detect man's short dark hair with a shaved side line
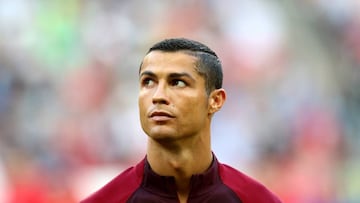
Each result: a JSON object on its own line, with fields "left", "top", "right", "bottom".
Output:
{"left": 143, "top": 38, "right": 223, "bottom": 94}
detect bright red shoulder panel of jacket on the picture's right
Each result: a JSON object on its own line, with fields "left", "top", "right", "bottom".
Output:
{"left": 219, "top": 163, "right": 281, "bottom": 203}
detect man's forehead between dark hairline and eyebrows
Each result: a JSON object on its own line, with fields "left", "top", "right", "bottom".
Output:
{"left": 140, "top": 51, "right": 199, "bottom": 75}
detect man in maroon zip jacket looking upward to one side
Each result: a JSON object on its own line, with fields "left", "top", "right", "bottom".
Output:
{"left": 83, "top": 38, "right": 280, "bottom": 203}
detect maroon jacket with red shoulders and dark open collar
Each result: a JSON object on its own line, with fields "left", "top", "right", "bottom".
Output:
{"left": 81, "top": 158, "right": 280, "bottom": 203}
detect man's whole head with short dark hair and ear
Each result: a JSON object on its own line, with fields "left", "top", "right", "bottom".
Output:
{"left": 139, "top": 39, "right": 225, "bottom": 140}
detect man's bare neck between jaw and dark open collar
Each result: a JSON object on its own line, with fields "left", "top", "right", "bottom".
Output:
{"left": 147, "top": 134, "right": 213, "bottom": 201}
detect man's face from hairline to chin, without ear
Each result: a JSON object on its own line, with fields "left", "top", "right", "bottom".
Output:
{"left": 139, "top": 51, "right": 210, "bottom": 140}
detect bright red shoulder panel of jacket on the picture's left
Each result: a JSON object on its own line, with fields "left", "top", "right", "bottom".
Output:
{"left": 81, "top": 160, "right": 145, "bottom": 203}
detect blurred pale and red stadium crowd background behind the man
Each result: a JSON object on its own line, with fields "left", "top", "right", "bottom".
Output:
{"left": 0, "top": 0, "right": 360, "bottom": 203}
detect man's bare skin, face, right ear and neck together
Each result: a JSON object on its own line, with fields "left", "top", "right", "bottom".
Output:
{"left": 138, "top": 51, "right": 226, "bottom": 202}
